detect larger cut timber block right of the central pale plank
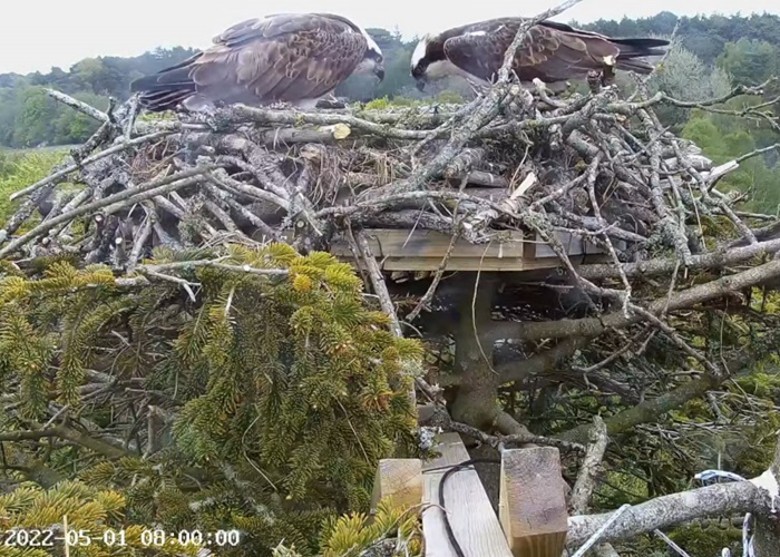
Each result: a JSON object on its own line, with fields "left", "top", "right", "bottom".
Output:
{"left": 498, "top": 447, "right": 569, "bottom": 557}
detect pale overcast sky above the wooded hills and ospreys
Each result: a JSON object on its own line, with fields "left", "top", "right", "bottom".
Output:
{"left": 0, "top": 0, "right": 780, "bottom": 73}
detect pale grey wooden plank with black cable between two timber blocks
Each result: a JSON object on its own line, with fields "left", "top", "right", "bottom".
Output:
{"left": 422, "top": 433, "right": 512, "bottom": 557}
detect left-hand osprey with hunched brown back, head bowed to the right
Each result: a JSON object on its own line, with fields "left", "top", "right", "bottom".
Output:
{"left": 130, "top": 13, "right": 385, "bottom": 112}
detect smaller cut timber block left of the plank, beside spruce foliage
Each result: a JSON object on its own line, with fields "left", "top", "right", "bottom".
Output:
{"left": 371, "top": 458, "right": 422, "bottom": 512}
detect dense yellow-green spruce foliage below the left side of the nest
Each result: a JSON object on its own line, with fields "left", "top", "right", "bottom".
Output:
{"left": 0, "top": 244, "right": 422, "bottom": 556}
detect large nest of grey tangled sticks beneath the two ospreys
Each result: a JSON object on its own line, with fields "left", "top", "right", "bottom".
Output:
{"left": 0, "top": 74, "right": 772, "bottom": 278}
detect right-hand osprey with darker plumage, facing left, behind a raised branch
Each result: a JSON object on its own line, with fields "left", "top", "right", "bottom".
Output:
{"left": 411, "top": 17, "right": 669, "bottom": 91}
